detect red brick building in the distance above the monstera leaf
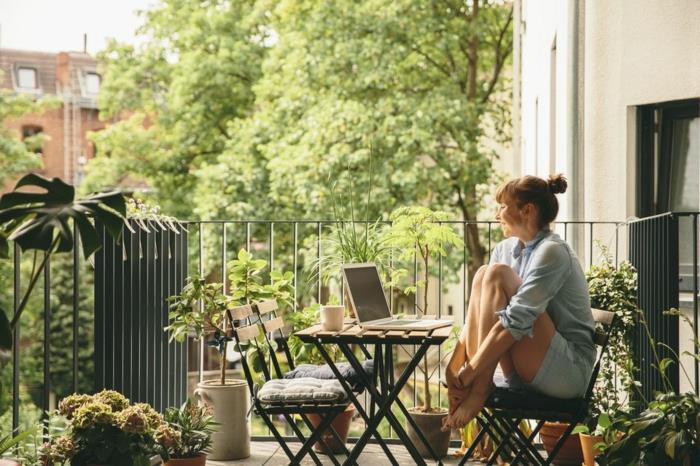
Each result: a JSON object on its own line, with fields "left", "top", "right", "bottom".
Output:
{"left": 0, "top": 49, "right": 105, "bottom": 188}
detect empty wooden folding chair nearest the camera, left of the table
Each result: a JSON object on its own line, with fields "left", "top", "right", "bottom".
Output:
{"left": 228, "top": 304, "right": 350, "bottom": 465}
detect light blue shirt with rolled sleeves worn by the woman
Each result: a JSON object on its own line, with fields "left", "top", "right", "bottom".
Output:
{"left": 490, "top": 229, "right": 596, "bottom": 363}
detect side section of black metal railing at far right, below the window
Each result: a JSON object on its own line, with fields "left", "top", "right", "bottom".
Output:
{"left": 629, "top": 212, "right": 700, "bottom": 400}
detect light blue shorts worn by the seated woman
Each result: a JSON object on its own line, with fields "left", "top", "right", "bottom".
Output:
{"left": 494, "top": 332, "right": 593, "bottom": 399}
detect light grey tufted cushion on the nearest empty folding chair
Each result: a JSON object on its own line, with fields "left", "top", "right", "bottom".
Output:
{"left": 257, "top": 377, "right": 348, "bottom": 403}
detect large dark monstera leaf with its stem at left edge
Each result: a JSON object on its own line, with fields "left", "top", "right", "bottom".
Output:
{"left": 0, "top": 174, "right": 126, "bottom": 349}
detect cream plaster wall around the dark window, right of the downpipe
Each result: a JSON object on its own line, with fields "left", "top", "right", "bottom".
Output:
{"left": 584, "top": 0, "right": 700, "bottom": 220}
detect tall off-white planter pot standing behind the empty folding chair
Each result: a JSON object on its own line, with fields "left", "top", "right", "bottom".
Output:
{"left": 194, "top": 379, "right": 250, "bottom": 461}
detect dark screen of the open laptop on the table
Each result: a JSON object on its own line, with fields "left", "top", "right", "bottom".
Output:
{"left": 343, "top": 265, "right": 391, "bottom": 322}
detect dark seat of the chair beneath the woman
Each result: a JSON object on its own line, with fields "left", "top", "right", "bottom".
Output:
{"left": 486, "top": 387, "right": 588, "bottom": 421}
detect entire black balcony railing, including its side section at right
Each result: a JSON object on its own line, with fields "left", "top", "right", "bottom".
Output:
{"left": 0, "top": 214, "right": 698, "bottom": 436}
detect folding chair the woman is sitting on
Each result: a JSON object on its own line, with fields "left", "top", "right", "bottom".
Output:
{"left": 459, "top": 309, "right": 615, "bottom": 466}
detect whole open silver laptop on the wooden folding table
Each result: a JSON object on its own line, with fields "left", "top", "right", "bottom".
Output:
{"left": 342, "top": 264, "right": 454, "bottom": 330}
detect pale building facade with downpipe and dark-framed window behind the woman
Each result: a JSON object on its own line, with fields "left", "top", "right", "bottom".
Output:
{"left": 513, "top": 0, "right": 700, "bottom": 390}
